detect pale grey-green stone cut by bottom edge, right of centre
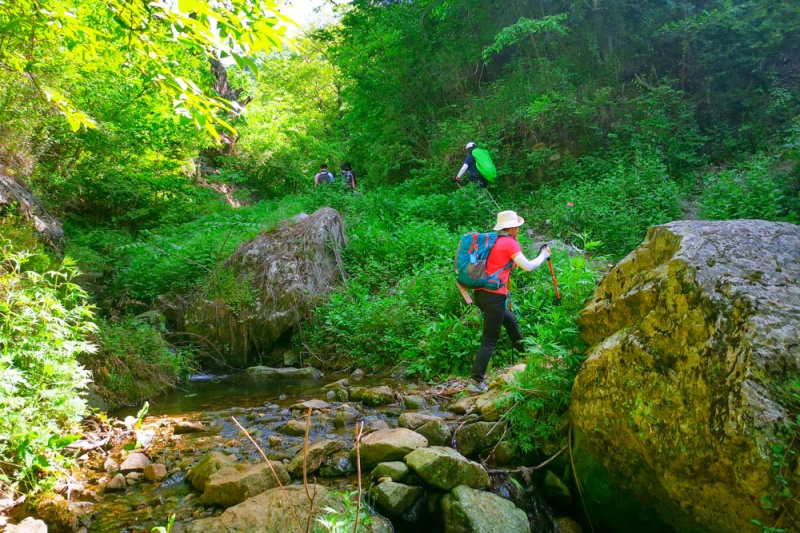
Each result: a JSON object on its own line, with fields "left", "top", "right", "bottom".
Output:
{"left": 441, "top": 485, "right": 531, "bottom": 533}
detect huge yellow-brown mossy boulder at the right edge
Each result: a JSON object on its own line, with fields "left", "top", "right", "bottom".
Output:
{"left": 570, "top": 220, "right": 800, "bottom": 532}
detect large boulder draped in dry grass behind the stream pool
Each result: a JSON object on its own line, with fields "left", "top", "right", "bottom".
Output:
{"left": 183, "top": 207, "right": 346, "bottom": 368}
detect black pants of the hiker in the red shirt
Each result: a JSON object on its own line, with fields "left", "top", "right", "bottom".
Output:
{"left": 472, "top": 290, "right": 524, "bottom": 381}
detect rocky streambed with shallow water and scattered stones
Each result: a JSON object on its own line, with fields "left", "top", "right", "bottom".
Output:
{"left": 8, "top": 367, "right": 580, "bottom": 533}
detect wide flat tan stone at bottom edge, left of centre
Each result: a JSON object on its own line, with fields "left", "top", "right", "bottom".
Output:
{"left": 188, "top": 484, "right": 344, "bottom": 533}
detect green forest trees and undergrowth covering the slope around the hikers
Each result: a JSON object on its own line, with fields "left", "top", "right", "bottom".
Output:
{"left": 0, "top": 0, "right": 800, "bottom": 516}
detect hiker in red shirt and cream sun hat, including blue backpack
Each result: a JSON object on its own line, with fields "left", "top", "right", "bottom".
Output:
{"left": 455, "top": 211, "right": 551, "bottom": 392}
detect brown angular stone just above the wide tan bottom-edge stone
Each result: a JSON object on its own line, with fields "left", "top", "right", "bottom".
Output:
{"left": 200, "top": 461, "right": 290, "bottom": 507}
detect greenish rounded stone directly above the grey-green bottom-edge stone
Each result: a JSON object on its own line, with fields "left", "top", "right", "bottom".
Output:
{"left": 406, "top": 446, "right": 489, "bottom": 490}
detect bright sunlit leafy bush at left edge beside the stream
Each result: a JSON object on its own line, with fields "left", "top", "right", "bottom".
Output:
{"left": 0, "top": 240, "right": 96, "bottom": 492}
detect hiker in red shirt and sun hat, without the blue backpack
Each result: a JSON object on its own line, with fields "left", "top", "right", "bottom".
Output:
{"left": 470, "top": 211, "right": 550, "bottom": 392}
